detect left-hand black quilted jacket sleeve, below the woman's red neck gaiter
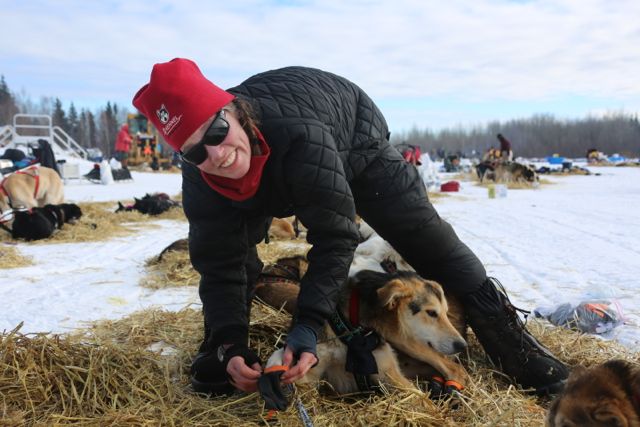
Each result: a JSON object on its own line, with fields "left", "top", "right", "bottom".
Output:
{"left": 182, "top": 165, "right": 249, "bottom": 345}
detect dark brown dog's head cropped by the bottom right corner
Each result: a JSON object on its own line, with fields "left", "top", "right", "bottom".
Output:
{"left": 547, "top": 360, "right": 640, "bottom": 427}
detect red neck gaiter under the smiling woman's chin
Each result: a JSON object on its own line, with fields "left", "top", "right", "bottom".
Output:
{"left": 200, "top": 129, "right": 271, "bottom": 202}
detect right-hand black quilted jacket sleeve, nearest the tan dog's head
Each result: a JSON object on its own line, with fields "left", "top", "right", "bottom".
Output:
{"left": 286, "top": 122, "right": 358, "bottom": 332}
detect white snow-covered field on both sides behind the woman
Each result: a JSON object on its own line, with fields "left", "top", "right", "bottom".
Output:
{"left": 0, "top": 160, "right": 640, "bottom": 350}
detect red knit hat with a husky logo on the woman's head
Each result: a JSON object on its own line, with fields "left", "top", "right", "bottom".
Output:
{"left": 133, "top": 58, "right": 235, "bottom": 151}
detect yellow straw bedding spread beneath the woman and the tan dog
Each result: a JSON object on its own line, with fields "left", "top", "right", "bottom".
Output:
{"left": 0, "top": 236, "right": 638, "bottom": 426}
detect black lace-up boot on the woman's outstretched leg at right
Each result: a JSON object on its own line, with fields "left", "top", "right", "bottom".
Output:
{"left": 462, "top": 278, "right": 569, "bottom": 395}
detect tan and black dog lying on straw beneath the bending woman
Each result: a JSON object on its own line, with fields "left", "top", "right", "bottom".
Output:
{"left": 256, "top": 257, "right": 467, "bottom": 393}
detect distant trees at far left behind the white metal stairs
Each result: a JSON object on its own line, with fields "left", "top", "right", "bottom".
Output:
{"left": 0, "top": 76, "right": 128, "bottom": 156}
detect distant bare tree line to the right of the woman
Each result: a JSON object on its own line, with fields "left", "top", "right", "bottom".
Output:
{"left": 391, "top": 112, "right": 640, "bottom": 158}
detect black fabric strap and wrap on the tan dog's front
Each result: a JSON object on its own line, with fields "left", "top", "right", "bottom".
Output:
{"left": 329, "top": 289, "right": 382, "bottom": 393}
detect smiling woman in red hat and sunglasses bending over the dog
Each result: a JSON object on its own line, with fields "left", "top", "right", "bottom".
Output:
{"left": 133, "top": 59, "right": 568, "bottom": 393}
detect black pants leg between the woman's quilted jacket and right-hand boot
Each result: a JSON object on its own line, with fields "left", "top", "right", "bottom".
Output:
{"left": 351, "top": 143, "right": 487, "bottom": 296}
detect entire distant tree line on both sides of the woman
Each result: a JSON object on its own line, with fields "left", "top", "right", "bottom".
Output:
{"left": 0, "top": 76, "right": 640, "bottom": 157}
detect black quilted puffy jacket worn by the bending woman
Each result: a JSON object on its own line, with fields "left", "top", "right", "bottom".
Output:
{"left": 183, "top": 67, "right": 388, "bottom": 343}
